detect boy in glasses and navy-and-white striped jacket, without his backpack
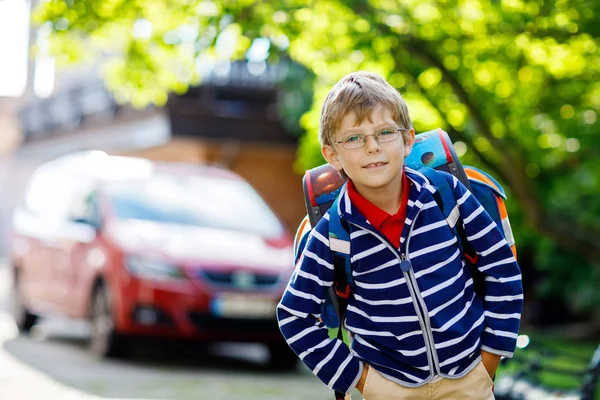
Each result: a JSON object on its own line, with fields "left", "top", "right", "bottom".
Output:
{"left": 277, "top": 72, "right": 523, "bottom": 400}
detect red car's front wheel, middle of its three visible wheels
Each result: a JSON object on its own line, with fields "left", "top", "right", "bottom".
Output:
{"left": 90, "top": 286, "right": 127, "bottom": 358}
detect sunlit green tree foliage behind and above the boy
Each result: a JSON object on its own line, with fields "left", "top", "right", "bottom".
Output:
{"left": 36, "top": 0, "right": 600, "bottom": 305}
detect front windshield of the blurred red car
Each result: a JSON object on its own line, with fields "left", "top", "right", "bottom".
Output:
{"left": 107, "top": 174, "right": 283, "bottom": 237}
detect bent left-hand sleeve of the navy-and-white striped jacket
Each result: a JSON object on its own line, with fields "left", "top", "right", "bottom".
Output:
{"left": 277, "top": 214, "right": 363, "bottom": 393}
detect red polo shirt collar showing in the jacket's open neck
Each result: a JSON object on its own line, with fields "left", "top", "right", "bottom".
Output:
{"left": 348, "top": 170, "right": 410, "bottom": 248}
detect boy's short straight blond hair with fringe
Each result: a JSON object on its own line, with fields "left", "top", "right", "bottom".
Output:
{"left": 319, "top": 71, "right": 412, "bottom": 146}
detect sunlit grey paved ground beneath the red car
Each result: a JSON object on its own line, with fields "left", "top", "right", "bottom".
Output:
{"left": 0, "top": 267, "right": 360, "bottom": 400}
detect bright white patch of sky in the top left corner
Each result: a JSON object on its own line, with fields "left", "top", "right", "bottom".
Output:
{"left": 0, "top": 0, "right": 29, "bottom": 97}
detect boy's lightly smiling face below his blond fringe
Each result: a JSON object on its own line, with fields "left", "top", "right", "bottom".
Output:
{"left": 321, "top": 105, "right": 415, "bottom": 196}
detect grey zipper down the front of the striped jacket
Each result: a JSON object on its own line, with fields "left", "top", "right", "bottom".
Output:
{"left": 348, "top": 210, "right": 440, "bottom": 376}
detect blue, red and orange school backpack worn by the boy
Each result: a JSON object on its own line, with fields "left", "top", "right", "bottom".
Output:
{"left": 294, "top": 129, "right": 516, "bottom": 332}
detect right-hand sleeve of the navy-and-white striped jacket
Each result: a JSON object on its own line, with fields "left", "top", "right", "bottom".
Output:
{"left": 451, "top": 177, "right": 523, "bottom": 358}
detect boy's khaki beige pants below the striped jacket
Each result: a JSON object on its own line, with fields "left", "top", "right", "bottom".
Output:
{"left": 346, "top": 362, "right": 494, "bottom": 400}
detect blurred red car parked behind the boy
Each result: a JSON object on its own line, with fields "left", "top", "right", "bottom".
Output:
{"left": 12, "top": 152, "right": 297, "bottom": 367}
